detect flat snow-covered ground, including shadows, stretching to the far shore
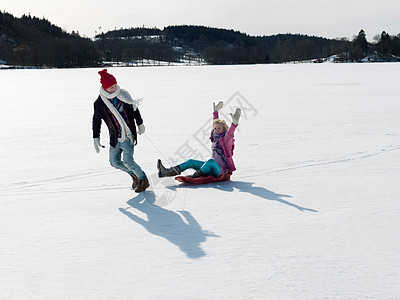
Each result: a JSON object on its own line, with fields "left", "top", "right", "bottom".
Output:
{"left": 0, "top": 63, "right": 400, "bottom": 299}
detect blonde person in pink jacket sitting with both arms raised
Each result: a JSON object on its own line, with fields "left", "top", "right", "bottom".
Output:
{"left": 157, "top": 101, "right": 241, "bottom": 178}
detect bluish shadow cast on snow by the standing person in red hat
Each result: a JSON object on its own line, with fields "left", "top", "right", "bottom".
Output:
{"left": 119, "top": 191, "right": 218, "bottom": 259}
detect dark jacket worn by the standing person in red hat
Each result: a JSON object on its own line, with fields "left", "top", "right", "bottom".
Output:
{"left": 92, "top": 96, "right": 143, "bottom": 147}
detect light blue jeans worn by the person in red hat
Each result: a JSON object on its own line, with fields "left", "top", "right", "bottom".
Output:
{"left": 109, "top": 139, "right": 146, "bottom": 179}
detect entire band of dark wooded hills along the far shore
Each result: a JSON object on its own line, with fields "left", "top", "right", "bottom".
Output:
{"left": 0, "top": 12, "right": 400, "bottom": 68}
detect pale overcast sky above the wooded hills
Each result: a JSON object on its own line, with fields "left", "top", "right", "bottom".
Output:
{"left": 0, "top": 0, "right": 400, "bottom": 41}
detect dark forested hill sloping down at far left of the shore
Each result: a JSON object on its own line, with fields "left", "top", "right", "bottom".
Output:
{"left": 0, "top": 12, "right": 101, "bottom": 68}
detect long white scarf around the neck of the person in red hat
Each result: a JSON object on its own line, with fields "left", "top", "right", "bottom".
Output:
{"left": 100, "top": 85, "right": 143, "bottom": 144}
